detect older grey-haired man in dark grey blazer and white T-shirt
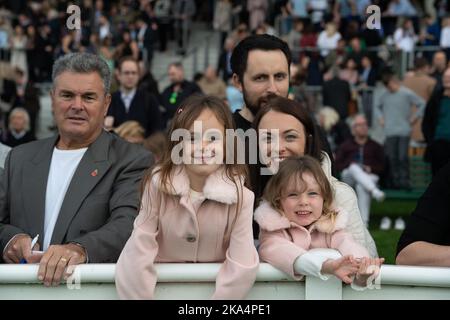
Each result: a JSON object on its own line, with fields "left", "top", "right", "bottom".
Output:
{"left": 0, "top": 53, "right": 152, "bottom": 286}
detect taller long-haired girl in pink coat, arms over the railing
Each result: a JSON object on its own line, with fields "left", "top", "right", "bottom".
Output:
{"left": 116, "top": 96, "right": 259, "bottom": 299}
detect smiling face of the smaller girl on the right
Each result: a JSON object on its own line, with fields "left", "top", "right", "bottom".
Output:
{"left": 280, "top": 172, "right": 324, "bottom": 227}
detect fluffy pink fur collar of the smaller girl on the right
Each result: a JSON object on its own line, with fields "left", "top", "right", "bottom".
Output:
{"left": 254, "top": 201, "right": 349, "bottom": 233}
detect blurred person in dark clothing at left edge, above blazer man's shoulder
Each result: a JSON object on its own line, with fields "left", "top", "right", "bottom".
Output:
{"left": 3, "top": 108, "right": 36, "bottom": 148}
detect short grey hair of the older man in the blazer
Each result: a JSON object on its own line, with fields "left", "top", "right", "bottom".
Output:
{"left": 52, "top": 52, "right": 111, "bottom": 93}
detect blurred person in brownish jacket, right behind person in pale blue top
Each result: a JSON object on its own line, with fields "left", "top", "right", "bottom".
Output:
{"left": 403, "top": 58, "right": 436, "bottom": 143}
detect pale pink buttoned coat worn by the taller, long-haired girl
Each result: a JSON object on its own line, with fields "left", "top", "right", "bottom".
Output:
{"left": 116, "top": 167, "right": 259, "bottom": 299}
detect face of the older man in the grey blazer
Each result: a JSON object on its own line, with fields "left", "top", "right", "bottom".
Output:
{"left": 51, "top": 72, "right": 111, "bottom": 148}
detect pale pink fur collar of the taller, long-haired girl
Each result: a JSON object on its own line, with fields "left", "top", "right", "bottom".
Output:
{"left": 152, "top": 166, "right": 244, "bottom": 204}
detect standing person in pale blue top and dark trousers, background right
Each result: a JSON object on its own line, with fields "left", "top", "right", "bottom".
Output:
{"left": 375, "top": 73, "right": 425, "bottom": 189}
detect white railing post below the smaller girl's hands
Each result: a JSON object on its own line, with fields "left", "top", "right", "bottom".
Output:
{"left": 305, "top": 277, "right": 342, "bottom": 300}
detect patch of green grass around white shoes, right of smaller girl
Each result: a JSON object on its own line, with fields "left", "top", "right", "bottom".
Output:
{"left": 369, "top": 200, "right": 417, "bottom": 264}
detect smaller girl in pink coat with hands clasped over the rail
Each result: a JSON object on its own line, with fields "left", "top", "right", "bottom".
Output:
{"left": 255, "top": 156, "right": 384, "bottom": 289}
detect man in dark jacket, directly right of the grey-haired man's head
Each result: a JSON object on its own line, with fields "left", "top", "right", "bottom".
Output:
{"left": 105, "top": 57, "right": 164, "bottom": 137}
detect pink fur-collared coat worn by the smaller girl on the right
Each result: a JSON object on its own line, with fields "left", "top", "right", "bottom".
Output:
{"left": 255, "top": 201, "right": 369, "bottom": 280}
